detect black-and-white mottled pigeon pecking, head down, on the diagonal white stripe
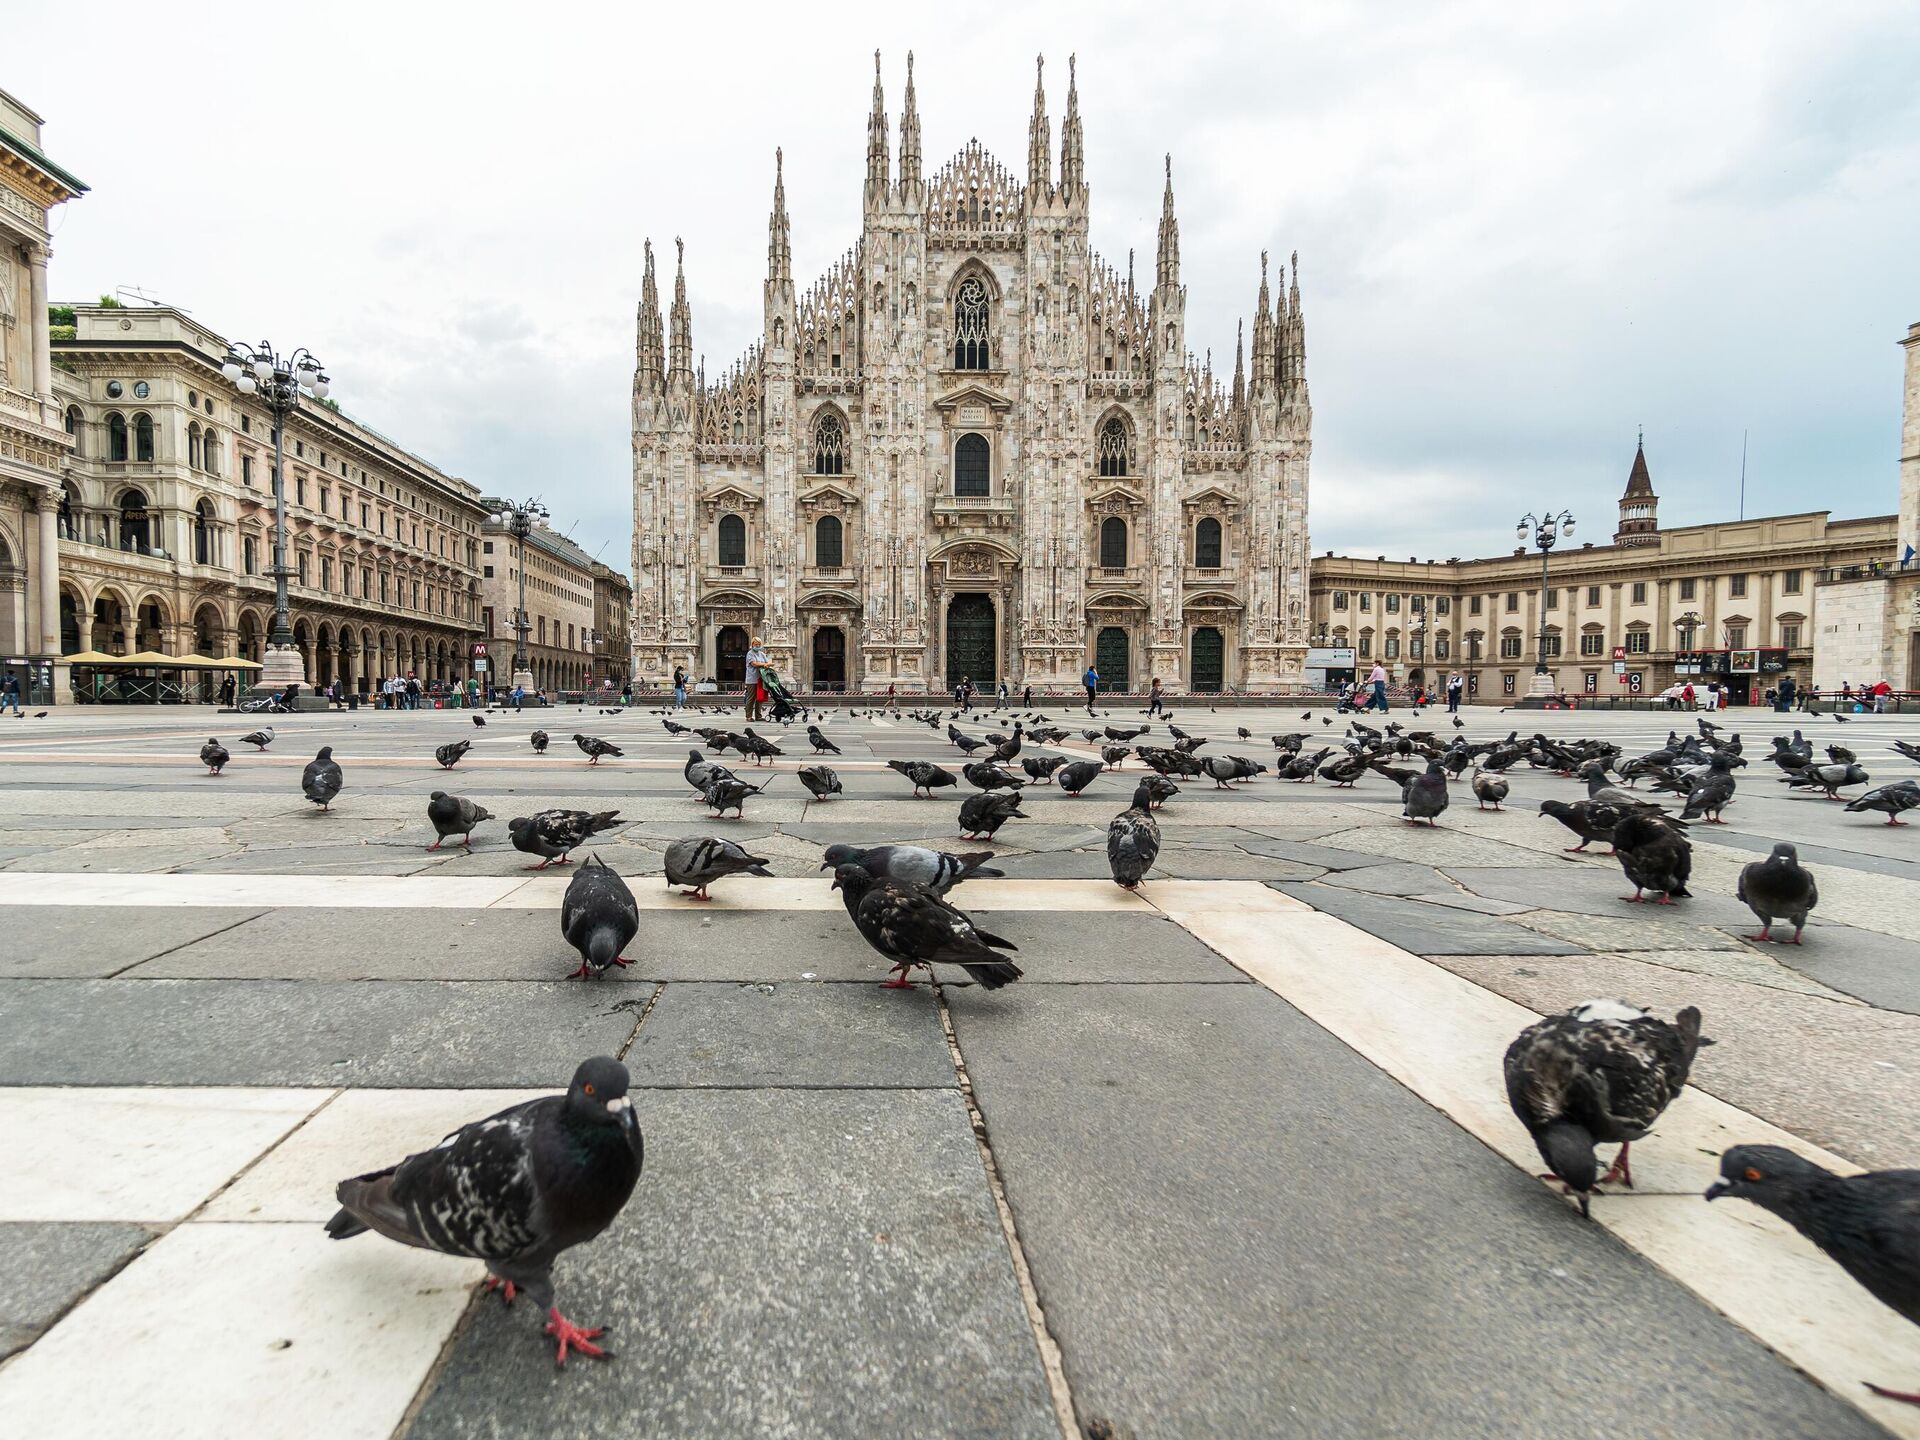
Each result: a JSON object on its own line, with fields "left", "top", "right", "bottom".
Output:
{"left": 1503, "top": 1000, "right": 1713, "bottom": 1215}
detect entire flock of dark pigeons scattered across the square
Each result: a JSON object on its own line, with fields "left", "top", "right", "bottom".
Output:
{"left": 176, "top": 710, "right": 1920, "bottom": 1405}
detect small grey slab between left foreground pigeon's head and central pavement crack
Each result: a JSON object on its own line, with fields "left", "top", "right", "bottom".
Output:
{"left": 626, "top": 981, "right": 956, "bottom": 1089}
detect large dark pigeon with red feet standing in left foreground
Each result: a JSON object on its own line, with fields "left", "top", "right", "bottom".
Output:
{"left": 326, "top": 1056, "right": 645, "bottom": 1365}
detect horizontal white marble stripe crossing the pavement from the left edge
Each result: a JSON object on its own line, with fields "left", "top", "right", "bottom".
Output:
{"left": 0, "top": 868, "right": 1152, "bottom": 914}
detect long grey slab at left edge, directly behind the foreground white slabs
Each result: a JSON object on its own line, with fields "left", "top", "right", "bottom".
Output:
{"left": 0, "top": 975, "right": 653, "bottom": 1087}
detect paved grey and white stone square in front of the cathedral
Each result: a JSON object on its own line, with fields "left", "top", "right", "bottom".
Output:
{"left": 0, "top": 705, "right": 1920, "bottom": 1440}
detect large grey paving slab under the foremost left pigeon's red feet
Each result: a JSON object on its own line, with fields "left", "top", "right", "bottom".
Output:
{"left": 409, "top": 1090, "right": 1060, "bottom": 1440}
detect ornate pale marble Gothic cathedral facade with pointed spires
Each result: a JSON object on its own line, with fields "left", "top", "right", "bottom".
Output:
{"left": 634, "top": 54, "right": 1311, "bottom": 693}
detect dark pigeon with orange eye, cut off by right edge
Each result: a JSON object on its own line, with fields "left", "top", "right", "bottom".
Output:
{"left": 1707, "top": 1144, "right": 1920, "bottom": 1405}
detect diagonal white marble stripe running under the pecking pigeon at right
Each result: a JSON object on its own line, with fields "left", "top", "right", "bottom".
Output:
{"left": 1148, "top": 887, "right": 1920, "bottom": 1440}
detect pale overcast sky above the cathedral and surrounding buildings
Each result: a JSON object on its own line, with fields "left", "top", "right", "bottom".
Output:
{"left": 18, "top": 0, "right": 1920, "bottom": 568}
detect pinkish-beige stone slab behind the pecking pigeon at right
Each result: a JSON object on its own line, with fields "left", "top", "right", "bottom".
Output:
{"left": 1432, "top": 954, "right": 1920, "bottom": 1169}
